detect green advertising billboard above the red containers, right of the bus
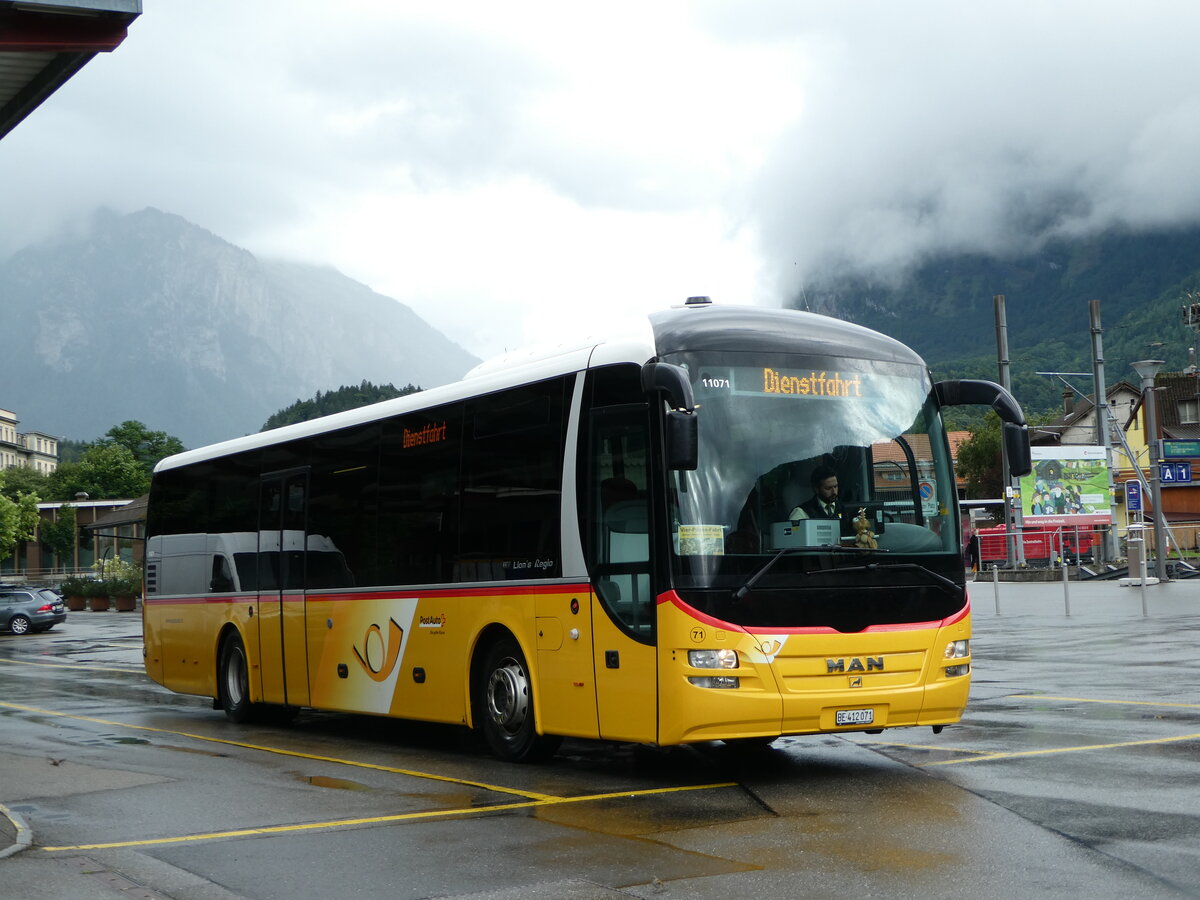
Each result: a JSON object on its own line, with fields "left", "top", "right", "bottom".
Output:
{"left": 1021, "top": 446, "right": 1112, "bottom": 526}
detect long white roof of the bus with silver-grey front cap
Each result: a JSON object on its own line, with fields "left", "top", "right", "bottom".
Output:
{"left": 155, "top": 302, "right": 925, "bottom": 472}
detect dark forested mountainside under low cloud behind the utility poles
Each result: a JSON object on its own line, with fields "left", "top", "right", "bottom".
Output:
{"left": 791, "top": 227, "right": 1200, "bottom": 422}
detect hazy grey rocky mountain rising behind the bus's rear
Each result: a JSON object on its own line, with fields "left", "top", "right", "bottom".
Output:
{"left": 0, "top": 209, "right": 478, "bottom": 446}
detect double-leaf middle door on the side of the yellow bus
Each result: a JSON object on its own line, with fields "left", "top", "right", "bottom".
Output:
{"left": 258, "top": 469, "right": 310, "bottom": 706}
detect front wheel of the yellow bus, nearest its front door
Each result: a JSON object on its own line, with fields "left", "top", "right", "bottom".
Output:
{"left": 475, "top": 637, "right": 562, "bottom": 762}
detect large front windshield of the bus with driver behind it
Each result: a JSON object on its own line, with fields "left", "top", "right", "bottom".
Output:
{"left": 666, "top": 352, "right": 961, "bottom": 625}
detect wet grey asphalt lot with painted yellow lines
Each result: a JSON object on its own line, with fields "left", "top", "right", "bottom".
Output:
{"left": 0, "top": 582, "right": 1200, "bottom": 900}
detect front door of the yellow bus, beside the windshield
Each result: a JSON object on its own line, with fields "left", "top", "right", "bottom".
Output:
{"left": 584, "top": 404, "right": 658, "bottom": 743}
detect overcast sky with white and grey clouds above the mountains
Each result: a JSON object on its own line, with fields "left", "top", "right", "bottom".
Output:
{"left": 0, "top": 0, "right": 1200, "bottom": 356}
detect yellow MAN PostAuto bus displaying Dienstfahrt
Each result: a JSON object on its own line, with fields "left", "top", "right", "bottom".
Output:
{"left": 144, "top": 298, "right": 1028, "bottom": 761}
